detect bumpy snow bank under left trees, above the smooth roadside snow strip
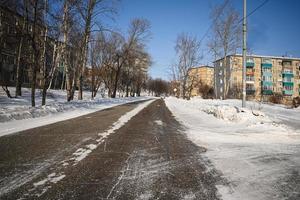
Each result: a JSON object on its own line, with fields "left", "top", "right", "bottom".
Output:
{"left": 0, "top": 89, "right": 148, "bottom": 123}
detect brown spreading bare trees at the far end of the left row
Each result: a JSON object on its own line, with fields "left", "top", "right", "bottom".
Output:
{"left": 90, "top": 19, "right": 151, "bottom": 98}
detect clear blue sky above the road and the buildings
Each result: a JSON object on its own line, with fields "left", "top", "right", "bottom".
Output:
{"left": 114, "top": 0, "right": 300, "bottom": 79}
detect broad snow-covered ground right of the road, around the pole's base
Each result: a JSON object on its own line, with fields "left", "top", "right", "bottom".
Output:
{"left": 165, "top": 97, "right": 300, "bottom": 200}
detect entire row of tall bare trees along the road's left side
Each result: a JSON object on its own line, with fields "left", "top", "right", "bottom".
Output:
{"left": 0, "top": 0, "right": 151, "bottom": 106}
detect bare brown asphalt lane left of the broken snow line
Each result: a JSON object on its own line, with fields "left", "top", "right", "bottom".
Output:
{"left": 0, "top": 103, "right": 148, "bottom": 199}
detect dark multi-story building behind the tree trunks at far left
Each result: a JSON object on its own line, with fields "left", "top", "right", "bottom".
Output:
{"left": 0, "top": 4, "right": 67, "bottom": 87}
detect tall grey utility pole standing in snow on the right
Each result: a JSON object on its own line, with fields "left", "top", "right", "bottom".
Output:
{"left": 242, "top": 0, "right": 247, "bottom": 107}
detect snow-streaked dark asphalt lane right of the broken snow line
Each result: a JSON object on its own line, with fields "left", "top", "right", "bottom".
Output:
{"left": 0, "top": 100, "right": 222, "bottom": 200}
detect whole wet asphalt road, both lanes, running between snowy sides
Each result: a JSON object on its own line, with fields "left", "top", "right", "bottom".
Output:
{"left": 0, "top": 100, "right": 221, "bottom": 200}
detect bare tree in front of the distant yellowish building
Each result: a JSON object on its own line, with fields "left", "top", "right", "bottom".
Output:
{"left": 172, "top": 33, "right": 202, "bottom": 98}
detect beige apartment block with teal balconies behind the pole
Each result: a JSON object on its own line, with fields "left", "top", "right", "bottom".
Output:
{"left": 214, "top": 54, "right": 300, "bottom": 101}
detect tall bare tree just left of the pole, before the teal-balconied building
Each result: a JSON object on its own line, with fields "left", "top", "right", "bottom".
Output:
{"left": 208, "top": 1, "right": 242, "bottom": 98}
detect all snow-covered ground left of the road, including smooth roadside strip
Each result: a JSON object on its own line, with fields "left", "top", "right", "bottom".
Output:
{"left": 0, "top": 88, "right": 150, "bottom": 136}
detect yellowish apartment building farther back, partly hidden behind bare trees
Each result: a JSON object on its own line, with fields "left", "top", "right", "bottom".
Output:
{"left": 189, "top": 66, "right": 214, "bottom": 97}
